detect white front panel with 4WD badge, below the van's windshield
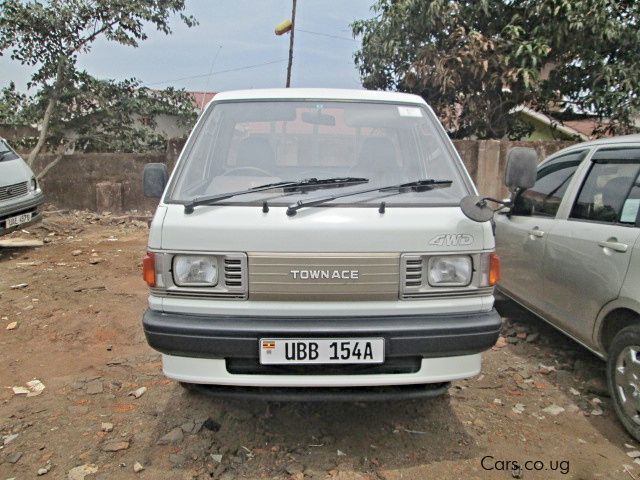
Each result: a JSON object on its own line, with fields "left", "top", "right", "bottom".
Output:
{"left": 149, "top": 204, "right": 494, "bottom": 253}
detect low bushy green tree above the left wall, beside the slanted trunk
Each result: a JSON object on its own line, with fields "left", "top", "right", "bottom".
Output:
{"left": 19, "top": 71, "right": 197, "bottom": 179}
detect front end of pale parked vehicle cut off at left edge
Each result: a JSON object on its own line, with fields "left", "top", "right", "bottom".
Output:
{"left": 0, "top": 138, "right": 44, "bottom": 236}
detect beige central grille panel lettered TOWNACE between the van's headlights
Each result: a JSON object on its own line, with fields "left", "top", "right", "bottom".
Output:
{"left": 248, "top": 253, "right": 400, "bottom": 301}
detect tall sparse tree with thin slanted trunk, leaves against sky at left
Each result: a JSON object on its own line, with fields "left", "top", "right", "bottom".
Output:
{"left": 0, "top": 0, "right": 196, "bottom": 172}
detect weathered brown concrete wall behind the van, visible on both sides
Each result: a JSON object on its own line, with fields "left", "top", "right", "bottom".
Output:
{"left": 35, "top": 140, "right": 572, "bottom": 213}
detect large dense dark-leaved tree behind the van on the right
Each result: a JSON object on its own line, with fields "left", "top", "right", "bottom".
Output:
{"left": 352, "top": 0, "right": 640, "bottom": 138}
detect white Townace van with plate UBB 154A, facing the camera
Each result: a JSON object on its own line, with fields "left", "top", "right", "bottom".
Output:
{"left": 143, "top": 89, "right": 510, "bottom": 400}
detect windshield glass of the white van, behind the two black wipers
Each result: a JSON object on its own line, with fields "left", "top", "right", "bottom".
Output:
{"left": 167, "top": 100, "right": 469, "bottom": 205}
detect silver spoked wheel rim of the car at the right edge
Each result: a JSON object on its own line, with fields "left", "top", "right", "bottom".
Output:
{"left": 615, "top": 345, "right": 640, "bottom": 425}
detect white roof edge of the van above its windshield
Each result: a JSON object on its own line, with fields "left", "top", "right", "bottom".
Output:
{"left": 212, "top": 88, "right": 426, "bottom": 105}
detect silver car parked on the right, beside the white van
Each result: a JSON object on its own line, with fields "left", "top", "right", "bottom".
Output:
{"left": 496, "top": 135, "right": 640, "bottom": 440}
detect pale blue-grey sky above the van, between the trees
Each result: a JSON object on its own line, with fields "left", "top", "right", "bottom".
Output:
{"left": 0, "top": 0, "right": 374, "bottom": 91}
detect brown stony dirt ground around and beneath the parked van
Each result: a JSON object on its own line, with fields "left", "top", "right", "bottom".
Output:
{"left": 0, "top": 207, "right": 640, "bottom": 480}
